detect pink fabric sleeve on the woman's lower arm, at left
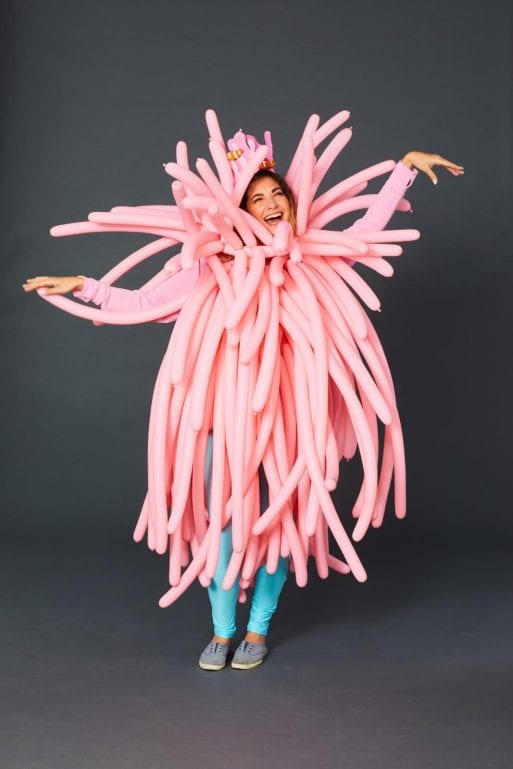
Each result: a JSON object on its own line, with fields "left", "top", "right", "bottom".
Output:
{"left": 73, "top": 256, "right": 204, "bottom": 323}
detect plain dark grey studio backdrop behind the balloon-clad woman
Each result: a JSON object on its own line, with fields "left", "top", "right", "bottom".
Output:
{"left": 0, "top": 0, "right": 513, "bottom": 767}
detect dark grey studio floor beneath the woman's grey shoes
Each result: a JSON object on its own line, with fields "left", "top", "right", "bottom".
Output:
{"left": 0, "top": 535, "right": 513, "bottom": 769}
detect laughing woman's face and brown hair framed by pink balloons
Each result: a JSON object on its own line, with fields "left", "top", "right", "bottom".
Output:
{"left": 241, "top": 169, "right": 296, "bottom": 233}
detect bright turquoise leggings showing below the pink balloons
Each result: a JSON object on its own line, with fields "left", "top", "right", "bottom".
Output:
{"left": 205, "top": 433, "right": 289, "bottom": 638}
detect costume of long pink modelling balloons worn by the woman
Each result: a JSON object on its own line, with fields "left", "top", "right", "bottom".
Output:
{"left": 40, "top": 110, "right": 419, "bottom": 607}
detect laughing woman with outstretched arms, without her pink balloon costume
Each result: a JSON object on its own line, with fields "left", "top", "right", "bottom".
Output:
{"left": 23, "top": 115, "right": 463, "bottom": 670}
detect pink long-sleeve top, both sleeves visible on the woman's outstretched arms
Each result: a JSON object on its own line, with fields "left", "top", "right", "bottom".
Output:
{"left": 73, "top": 161, "right": 418, "bottom": 322}
